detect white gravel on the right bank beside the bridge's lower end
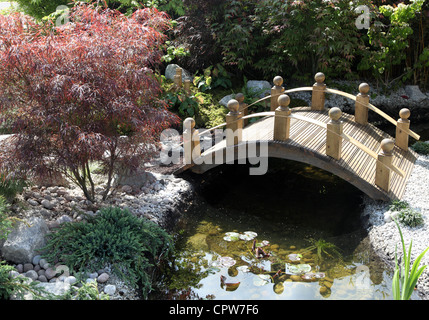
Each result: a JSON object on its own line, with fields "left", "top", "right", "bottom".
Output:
{"left": 363, "top": 156, "right": 429, "bottom": 299}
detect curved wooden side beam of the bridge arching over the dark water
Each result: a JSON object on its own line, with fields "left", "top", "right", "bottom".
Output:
{"left": 184, "top": 141, "right": 398, "bottom": 201}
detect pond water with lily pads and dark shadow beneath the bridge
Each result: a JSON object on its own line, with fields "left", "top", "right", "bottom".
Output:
{"left": 151, "top": 159, "right": 418, "bottom": 300}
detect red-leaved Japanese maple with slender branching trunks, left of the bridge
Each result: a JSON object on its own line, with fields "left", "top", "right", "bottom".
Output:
{"left": 0, "top": 3, "right": 177, "bottom": 200}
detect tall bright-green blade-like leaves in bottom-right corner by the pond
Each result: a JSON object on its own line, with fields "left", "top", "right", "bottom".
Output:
{"left": 392, "top": 219, "right": 429, "bottom": 300}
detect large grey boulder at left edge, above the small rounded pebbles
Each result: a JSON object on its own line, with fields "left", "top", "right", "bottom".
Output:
{"left": 1, "top": 217, "right": 49, "bottom": 263}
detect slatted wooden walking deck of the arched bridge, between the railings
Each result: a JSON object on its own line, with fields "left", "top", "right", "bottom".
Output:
{"left": 196, "top": 107, "right": 417, "bottom": 199}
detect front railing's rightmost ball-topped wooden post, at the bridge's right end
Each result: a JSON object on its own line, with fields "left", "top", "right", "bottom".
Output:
{"left": 375, "top": 139, "right": 395, "bottom": 192}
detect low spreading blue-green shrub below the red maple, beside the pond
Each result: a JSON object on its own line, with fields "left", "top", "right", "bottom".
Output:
{"left": 43, "top": 208, "right": 173, "bottom": 295}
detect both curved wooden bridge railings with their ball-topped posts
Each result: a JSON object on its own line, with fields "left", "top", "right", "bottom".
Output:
{"left": 179, "top": 73, "right": 420, "bottom": 192}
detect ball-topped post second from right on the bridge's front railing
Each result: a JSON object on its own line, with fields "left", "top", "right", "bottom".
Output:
{"left": 326, "top": 107, "right": 343, "bottom": 160}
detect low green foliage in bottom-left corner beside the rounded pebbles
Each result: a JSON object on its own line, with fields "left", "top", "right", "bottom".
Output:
{"left": 0, "top": 261, "right": 44, "bottom": 300}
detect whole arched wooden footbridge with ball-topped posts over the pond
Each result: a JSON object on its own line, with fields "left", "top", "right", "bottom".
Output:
{"left": 171, "top": 73, "right": 420, "bottom": 201}
